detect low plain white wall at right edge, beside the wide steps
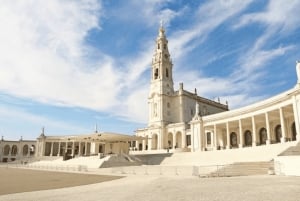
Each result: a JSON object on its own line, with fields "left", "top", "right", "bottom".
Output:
{"left": 274, "top": 156, "right": 300, "bottom": 176}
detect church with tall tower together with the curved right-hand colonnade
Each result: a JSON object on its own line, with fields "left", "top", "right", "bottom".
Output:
{"left": 135, "top": 26, "right": 300, "bottom": 151}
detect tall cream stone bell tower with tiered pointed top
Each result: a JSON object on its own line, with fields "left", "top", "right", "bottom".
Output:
{"left": 148, "top": 23, "right": 174, "bottom": 126}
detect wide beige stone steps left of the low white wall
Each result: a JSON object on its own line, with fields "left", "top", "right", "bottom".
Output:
{"left": 207, "top": 161, "right": 274, "bottom": 177}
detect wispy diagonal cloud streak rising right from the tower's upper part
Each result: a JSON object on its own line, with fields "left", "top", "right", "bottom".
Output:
{"left": 170, "top": 0, "right": 252, "bottom": 60}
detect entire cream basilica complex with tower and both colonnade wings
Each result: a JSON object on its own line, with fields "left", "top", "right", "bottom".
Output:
{"left": 0, "top": 26, "right": 300, "bottom": 162}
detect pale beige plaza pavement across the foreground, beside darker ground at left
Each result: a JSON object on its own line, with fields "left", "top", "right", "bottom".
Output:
{"left": 0, "top": 170, "right": 300, "bottom": 201}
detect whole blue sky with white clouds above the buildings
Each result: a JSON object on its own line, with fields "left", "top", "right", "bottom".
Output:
{"left": 0, "top": 0, "right": 300, "bottom": 140}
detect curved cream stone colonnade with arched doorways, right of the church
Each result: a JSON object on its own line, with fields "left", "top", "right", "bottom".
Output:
{"left": 201, "top": 103, "right": 300, "bottom": 149}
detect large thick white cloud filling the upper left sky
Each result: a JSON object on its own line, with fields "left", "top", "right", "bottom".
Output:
{"left": 0, "top": 0, "right": 120, "bottom": 110}
